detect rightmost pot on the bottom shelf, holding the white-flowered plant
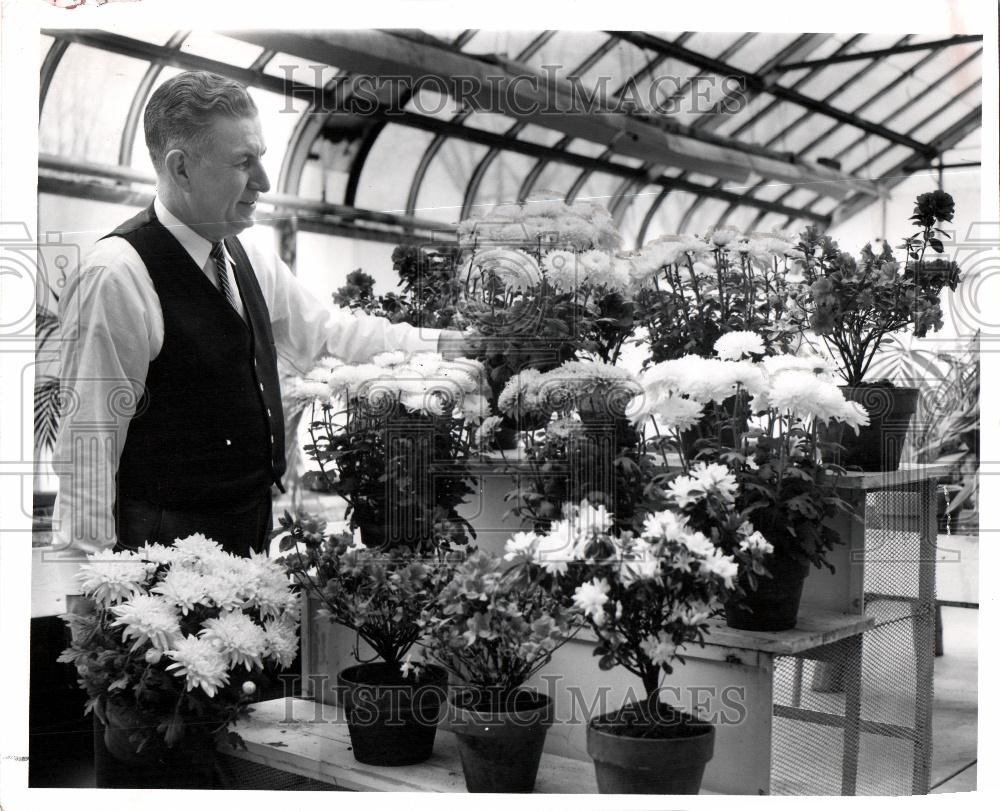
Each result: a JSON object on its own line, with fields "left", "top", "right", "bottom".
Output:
{"left": 587, "top": 704, "right": 715, "bottom": 794}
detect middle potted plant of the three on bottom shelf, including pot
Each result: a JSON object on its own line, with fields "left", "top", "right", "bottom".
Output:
{"left": 420, "top": 550, "right": 575, "bottom": 793}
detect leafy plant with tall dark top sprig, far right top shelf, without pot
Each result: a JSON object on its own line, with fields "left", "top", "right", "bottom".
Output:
{"left": 789, "top": 191, "right": 961, "bottom": 386}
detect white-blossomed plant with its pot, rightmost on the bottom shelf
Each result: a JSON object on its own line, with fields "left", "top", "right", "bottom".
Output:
{"left": 507, "top": 501, "right": 738, "bottom": 794}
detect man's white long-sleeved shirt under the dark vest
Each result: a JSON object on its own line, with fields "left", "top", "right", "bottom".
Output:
{"left": 53, "top": 199, "right": 441, "bottom": 552}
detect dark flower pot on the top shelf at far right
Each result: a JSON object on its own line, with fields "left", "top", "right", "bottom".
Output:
{"left": 820, "top": 383, "right": 920, "bottom": 472}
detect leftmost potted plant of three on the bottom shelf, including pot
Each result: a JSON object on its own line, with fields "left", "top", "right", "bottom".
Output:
{"left": 278, "top": 513, "right": 464, "bottom": 766}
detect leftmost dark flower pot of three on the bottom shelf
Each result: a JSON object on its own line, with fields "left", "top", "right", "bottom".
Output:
{"left": 337, "top": 662, "right": 448, "bottom": 766}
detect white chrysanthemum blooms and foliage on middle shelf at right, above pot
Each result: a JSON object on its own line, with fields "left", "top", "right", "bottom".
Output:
{"left": 632, "top": 333, "right": 868, "bottom": 576}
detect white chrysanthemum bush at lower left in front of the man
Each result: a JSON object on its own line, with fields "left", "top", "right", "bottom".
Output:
{"left": 59, "top": 535, "right": 299, "bottom": 752}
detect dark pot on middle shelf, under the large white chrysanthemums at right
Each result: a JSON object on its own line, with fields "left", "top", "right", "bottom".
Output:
{"left": 726, "top": 555, "right": 809, "bottom": 631}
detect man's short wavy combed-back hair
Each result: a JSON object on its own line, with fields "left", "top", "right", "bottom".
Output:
{"left": 142, "top": 70, "right": 257, "bottom": 173}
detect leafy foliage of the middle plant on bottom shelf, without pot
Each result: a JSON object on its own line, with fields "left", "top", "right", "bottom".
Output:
{"left": 410, "top": 550, "right": 575, "bottom": 704}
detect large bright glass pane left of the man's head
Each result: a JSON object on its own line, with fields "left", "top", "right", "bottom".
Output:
{"left": 38, "top": 44, "right": 148, "bottom": 164}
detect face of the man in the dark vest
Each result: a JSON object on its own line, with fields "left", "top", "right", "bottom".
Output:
{"left": 188, "top": 116, "right": 271, "bottom": 242}
